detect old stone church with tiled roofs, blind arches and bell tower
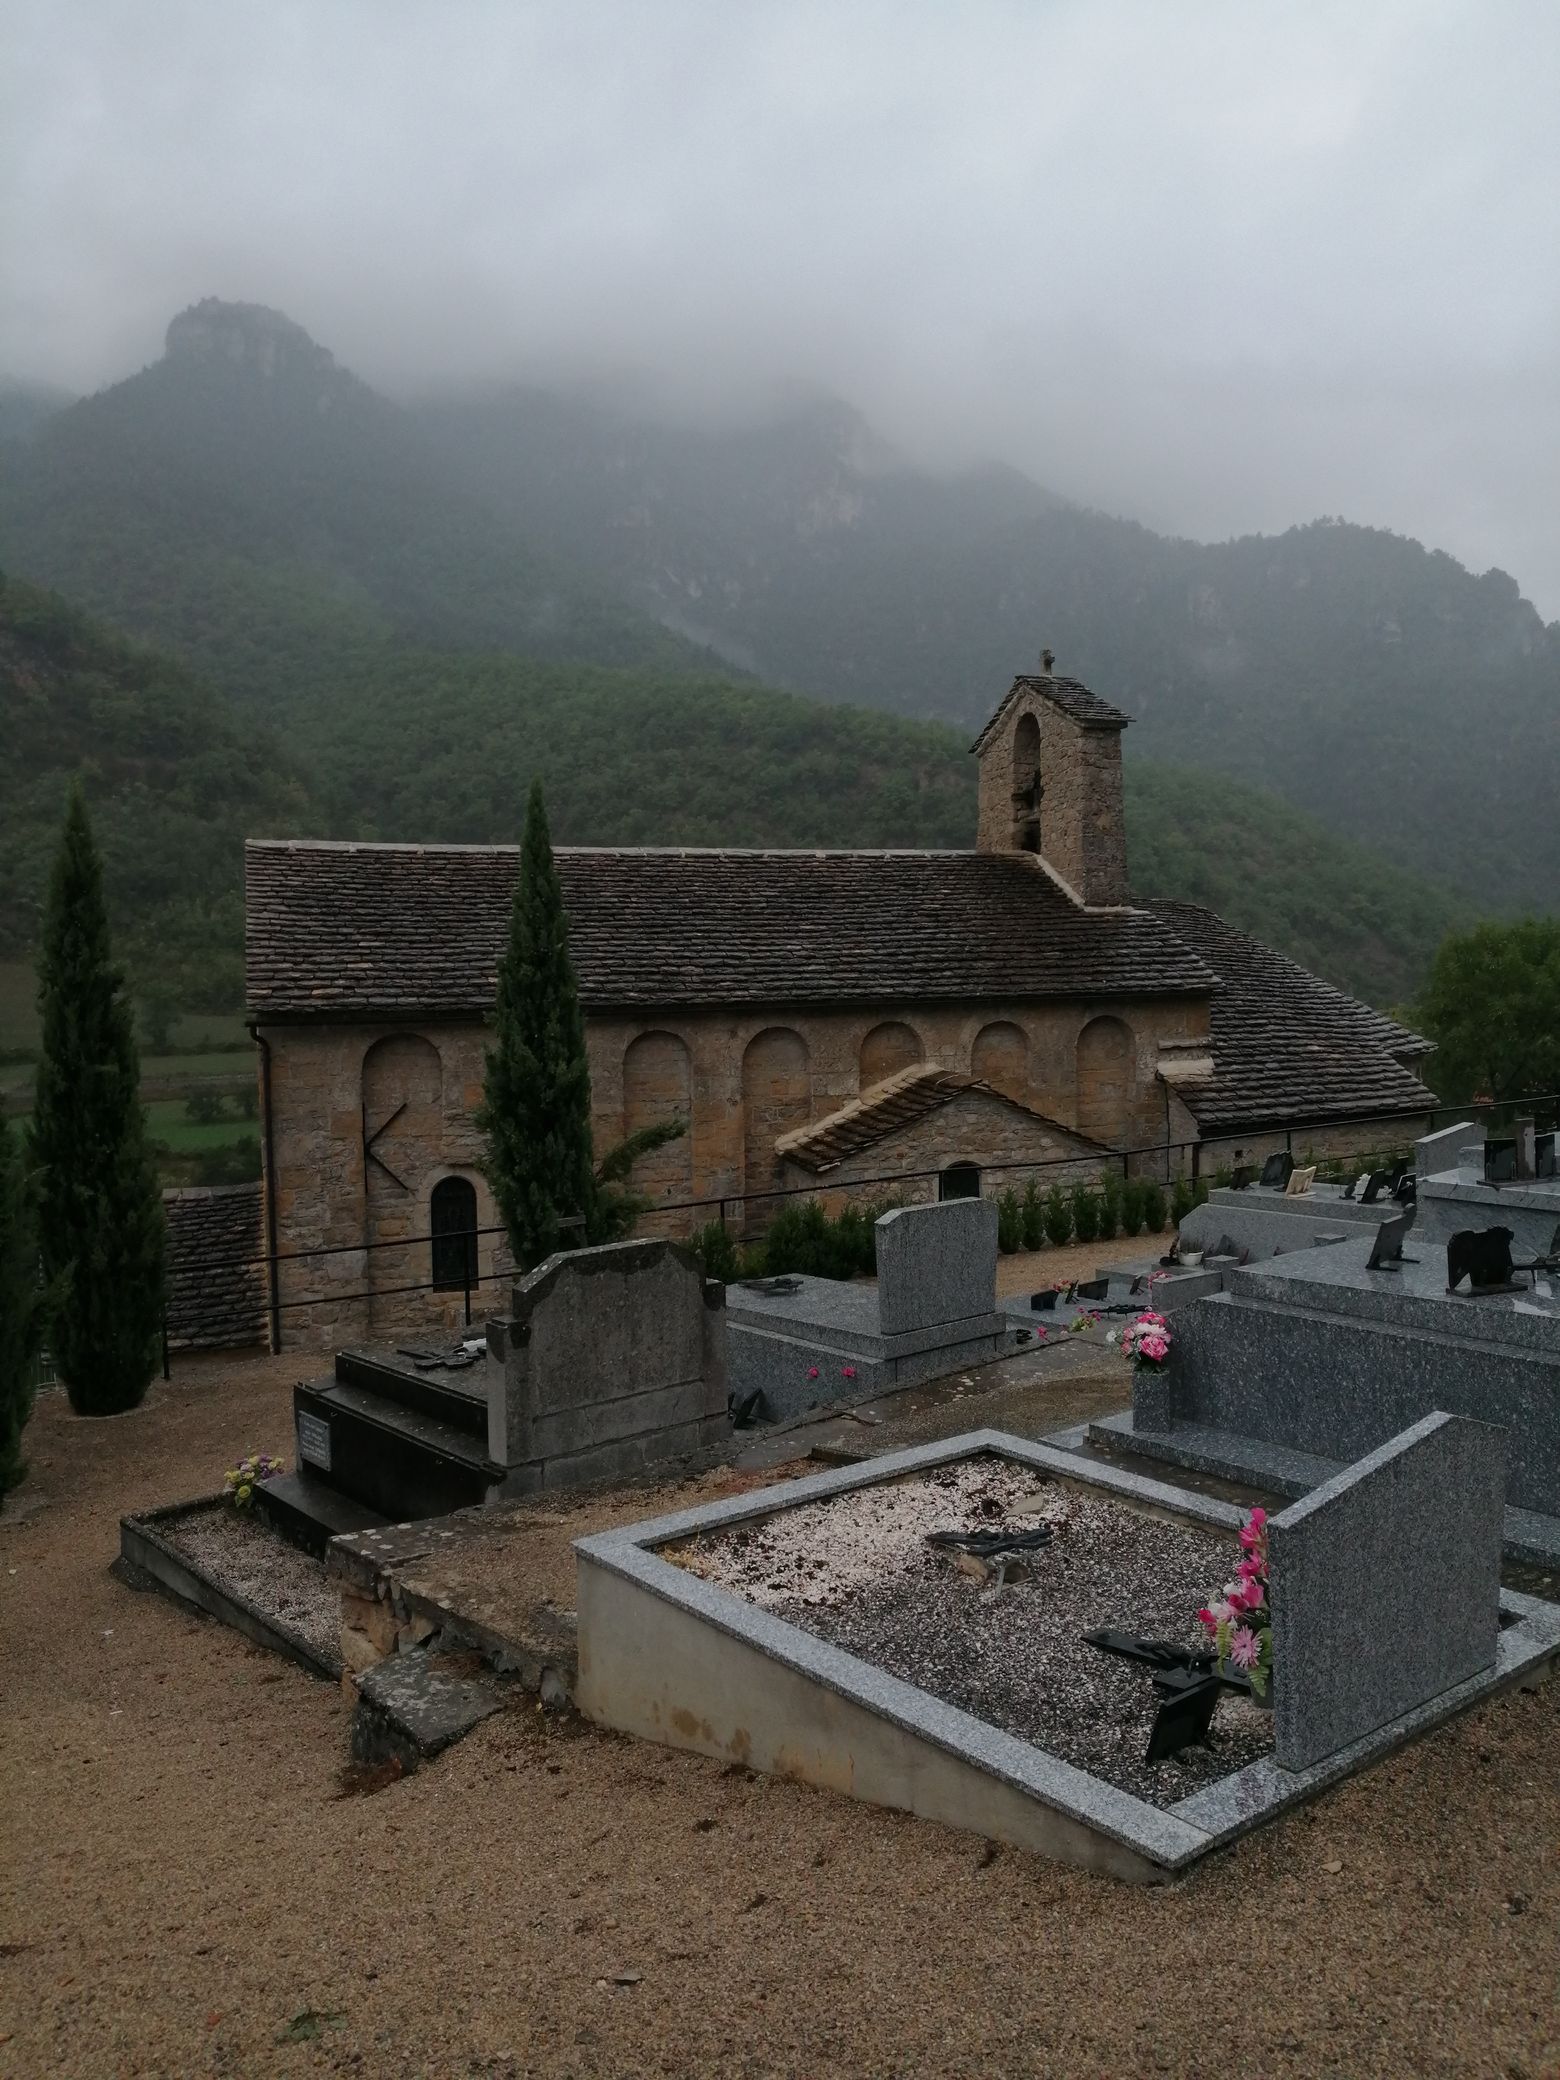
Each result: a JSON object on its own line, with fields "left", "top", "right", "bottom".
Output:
{"left": 245, "top": 657, "right": 1433, "bottom": 1344}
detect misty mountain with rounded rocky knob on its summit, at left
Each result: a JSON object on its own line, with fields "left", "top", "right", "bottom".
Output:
{"left": 0, "top": 300, "right": 709, "bottom": 703}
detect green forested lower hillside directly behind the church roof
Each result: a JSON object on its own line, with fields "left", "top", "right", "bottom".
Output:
{"left": 0, "top": 578, "right": 1466, "bottom": 1013}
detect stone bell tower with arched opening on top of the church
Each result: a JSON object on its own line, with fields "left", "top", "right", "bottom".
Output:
{"left": 969, "top": 651, "right": 1132, "bottom": 909}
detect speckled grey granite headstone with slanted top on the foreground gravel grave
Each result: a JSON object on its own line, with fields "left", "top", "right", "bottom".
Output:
{"left": 1269, "top": 1412, "right": 1506, "bottom": 1770}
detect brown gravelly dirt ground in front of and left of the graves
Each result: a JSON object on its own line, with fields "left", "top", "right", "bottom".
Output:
{"left": 0, "top": 1339, "right": 1560, "bottom": 2080}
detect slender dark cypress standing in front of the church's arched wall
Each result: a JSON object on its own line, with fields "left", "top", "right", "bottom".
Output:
{"left": 476, "top": 780, "right": 595, "bottom": 1271}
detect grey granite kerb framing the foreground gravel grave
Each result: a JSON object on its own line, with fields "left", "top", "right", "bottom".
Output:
{"left": 574, "top": 1429, "right": 1560, "bottom": 1876}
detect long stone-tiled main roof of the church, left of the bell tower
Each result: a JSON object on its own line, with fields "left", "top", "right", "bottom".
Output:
{"left": 245, "top": 838, "right": 1215, "bottom": 1021}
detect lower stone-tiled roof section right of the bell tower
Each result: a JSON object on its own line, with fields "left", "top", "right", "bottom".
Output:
{"left": 1152, "top": 903, "right": 1435, "bottom": 1134}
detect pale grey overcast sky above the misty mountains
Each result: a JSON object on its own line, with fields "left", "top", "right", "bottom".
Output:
{"left": 0, "top": 0, "right": 1560, "bottom": 616}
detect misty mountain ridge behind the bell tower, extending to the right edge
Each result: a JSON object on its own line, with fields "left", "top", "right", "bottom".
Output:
{"left": 422, "top": 389, "right": 1560, "bottom": 909}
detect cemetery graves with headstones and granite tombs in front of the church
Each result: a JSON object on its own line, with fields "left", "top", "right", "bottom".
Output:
{"left": 112, "top": 1186, "right": 1560, "bottom": 1882}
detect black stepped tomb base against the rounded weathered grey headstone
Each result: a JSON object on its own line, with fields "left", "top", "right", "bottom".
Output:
{"left": 293, "top": 1379, "right": 503, "bottom": 1523}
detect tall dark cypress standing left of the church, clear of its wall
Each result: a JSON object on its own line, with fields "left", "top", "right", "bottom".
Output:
{"left": 31, "top": 786, "right": 164, "bottom": 1416}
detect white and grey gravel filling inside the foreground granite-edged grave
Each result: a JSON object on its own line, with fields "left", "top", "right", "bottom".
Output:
{"left": 661, "top": 1454, "right": 1273, "bottom": 1805}
